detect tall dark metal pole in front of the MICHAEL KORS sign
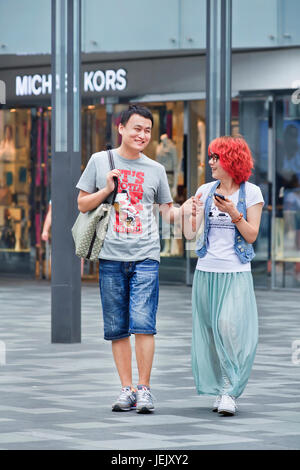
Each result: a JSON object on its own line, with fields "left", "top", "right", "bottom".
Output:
{"left": 51, "top": 0, "right": 81, "bottom": 343}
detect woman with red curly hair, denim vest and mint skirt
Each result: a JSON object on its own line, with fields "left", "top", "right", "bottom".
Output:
{"left": 185, "top": 137, "right": 264, "bottom": 415}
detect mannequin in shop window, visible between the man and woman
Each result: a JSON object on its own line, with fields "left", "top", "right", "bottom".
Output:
{"left": 156, "top": 134, "right": 178, "bottom": 256}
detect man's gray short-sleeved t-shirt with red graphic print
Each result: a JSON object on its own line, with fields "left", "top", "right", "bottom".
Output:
{"left": 76, "top": 150, "right": 172, "bottom": 261}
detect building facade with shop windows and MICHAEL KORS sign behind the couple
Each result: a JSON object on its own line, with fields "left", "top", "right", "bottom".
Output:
{"left": 0, "top": 0, "right": 300, "bottom": 288}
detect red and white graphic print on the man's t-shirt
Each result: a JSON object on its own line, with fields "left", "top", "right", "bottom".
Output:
{"left": 114, "top": 170, "right": 145, "bottom": 234}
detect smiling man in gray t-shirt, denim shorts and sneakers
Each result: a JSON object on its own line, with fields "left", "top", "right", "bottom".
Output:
{"left": 77, "top": 106, "right": 191, "bottom": 413}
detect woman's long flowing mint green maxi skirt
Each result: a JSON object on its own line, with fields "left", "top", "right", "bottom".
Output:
{"left": 192, "top": 270, "right": 258, "bottom": 398}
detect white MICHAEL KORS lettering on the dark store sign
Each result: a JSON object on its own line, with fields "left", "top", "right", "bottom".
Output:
{"left": 16, "top": 69, "right": 127, "bottom": 96}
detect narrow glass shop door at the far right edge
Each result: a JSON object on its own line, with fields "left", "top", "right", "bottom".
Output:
{"left": 273, "top": 92, "right": 300, "bottom": 288}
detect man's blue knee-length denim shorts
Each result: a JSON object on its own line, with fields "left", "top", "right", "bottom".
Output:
{"left": 99, "top": 259, "right": 159, "bottom": 340}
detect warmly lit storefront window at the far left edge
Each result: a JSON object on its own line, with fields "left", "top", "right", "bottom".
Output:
{"left": 0, "top": 109, "right": 31, "bottom": 264}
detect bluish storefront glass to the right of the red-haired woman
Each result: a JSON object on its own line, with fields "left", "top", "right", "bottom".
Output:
{"left": 240, "top": 93, "right": 300, "bottom": 288}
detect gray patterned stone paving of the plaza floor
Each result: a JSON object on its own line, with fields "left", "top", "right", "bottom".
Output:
{"left": 0, "top": 279, "right": 300, "bottom": 451}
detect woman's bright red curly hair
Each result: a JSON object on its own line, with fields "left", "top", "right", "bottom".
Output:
{"left": 208, "top": 136, "right": 254, "bottom": 184}
